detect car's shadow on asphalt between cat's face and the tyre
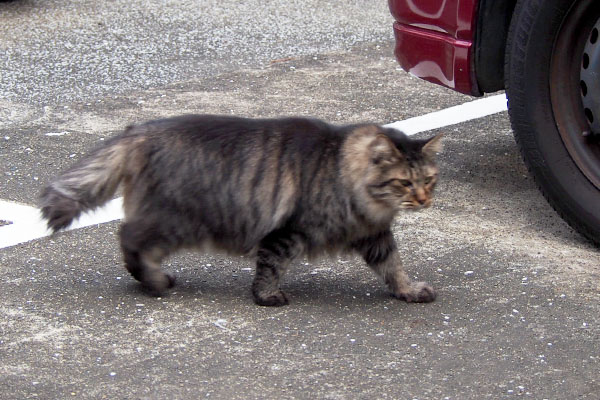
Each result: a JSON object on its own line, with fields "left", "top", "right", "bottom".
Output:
{"left": 432, "top": 114, "right": 590, "bottom": 245}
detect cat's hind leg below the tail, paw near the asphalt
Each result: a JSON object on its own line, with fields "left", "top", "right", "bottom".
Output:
{"left": 120, "top": 222, "right": 175, "bottom": 296}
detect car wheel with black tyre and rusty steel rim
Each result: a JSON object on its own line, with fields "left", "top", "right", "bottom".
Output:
{"left": 505, "top": 0, "right": 600, "bottom": 245}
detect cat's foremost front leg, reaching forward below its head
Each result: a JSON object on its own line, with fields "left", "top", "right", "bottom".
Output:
{"left": 353, "top": 230, "right": 436, "bottom": 303}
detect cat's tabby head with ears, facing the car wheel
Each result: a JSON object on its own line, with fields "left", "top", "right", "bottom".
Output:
{"left": 364, "top": 129, "right": 442, "bottom": 210}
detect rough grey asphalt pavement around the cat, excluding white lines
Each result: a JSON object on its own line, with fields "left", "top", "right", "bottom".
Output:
{"left": 0, "top": 0, "right": 600, "bottom": 399}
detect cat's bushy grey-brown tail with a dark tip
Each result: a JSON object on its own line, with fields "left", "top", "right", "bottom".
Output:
{"left": 41, "top": 137, "right": 137, "bottom": 232}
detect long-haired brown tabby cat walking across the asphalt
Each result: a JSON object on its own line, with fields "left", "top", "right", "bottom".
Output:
{"left": 41, "top": 115, "right": 441, "bottom": 306}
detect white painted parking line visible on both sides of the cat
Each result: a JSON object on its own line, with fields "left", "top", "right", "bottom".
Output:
{"left": 0, "top": 94, "right": 506, "bottom": 249}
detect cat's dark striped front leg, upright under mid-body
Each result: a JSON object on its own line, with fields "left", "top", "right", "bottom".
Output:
{"left": 252, "top": 230, "right": 303, "bottom": 306}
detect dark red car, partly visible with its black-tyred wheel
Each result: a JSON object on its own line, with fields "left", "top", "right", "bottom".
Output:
{"left": 388, "top": 0, "right": 600, "bottom": 245}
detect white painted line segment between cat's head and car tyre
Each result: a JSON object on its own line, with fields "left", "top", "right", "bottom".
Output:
{"left": 384, "top": 94, "right": 507, "bottom": 135}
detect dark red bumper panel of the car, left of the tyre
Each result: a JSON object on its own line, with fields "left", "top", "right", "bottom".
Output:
{"left": 388, "top": 0, "right": 482, "bottom": 96}
